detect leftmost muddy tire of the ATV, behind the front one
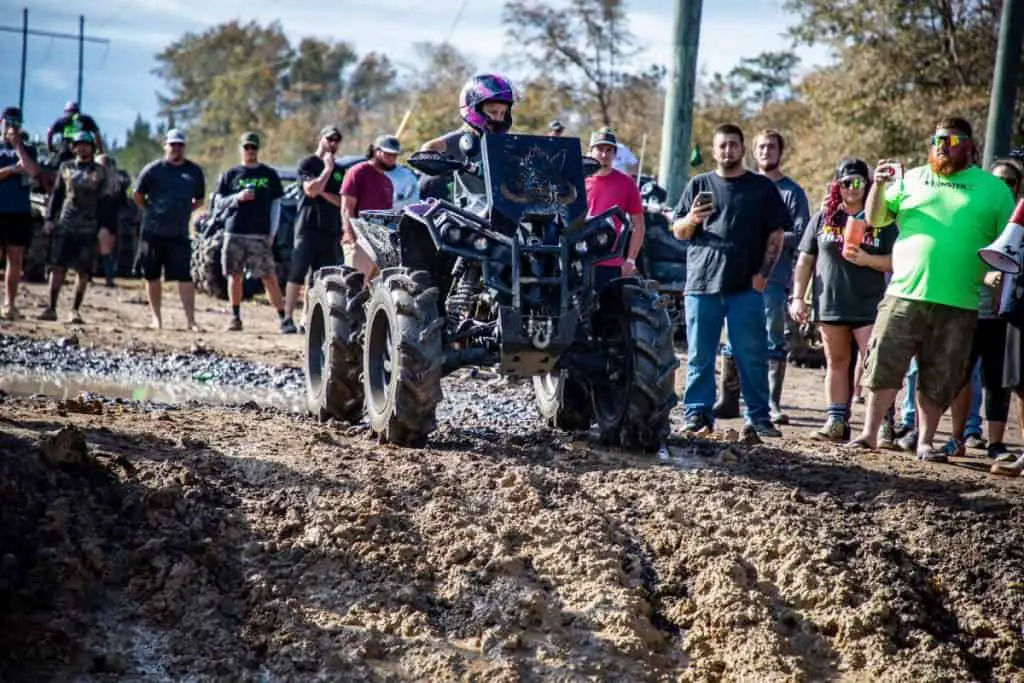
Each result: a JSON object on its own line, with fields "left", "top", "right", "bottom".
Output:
{"left": 305, "top": 266, "right": 369, "bottom": 423}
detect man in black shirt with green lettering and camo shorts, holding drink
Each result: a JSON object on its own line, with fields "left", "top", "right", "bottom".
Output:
{"left": 214, "top": 133, "right": 285, "bottom": 331}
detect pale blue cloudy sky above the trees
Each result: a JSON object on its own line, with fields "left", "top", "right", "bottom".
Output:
{"left": 0, "top": 0, "right": 828, "bottom": 145}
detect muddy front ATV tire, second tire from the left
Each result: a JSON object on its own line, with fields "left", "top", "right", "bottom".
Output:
{"left": 362, "top": 267, "right": 444, "bottom": 447}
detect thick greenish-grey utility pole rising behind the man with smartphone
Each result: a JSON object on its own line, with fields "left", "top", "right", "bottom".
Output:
{"left": 657, "top": 0, "right": 703, "bottom": 205}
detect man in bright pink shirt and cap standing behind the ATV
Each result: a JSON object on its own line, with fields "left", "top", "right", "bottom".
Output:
{"left": 587, "top": 128, "right": 644, "bottom": 291}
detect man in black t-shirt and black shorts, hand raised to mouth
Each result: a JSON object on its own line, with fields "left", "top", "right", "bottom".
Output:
{"left": 281, "top": 126, "right": 344, "bottom": 334}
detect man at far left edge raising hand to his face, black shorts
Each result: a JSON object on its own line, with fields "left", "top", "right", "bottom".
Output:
{"left": 0, "top": 106, "right": 39, "bottom": 321}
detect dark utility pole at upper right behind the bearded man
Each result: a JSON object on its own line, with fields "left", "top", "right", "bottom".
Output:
{"left": 985, "top": 0, "right": 1024, "bottom": 168}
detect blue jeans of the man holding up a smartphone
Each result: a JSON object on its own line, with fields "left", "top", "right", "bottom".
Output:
{"left": 683, "top": 290, "right": 771, "bottom": 423}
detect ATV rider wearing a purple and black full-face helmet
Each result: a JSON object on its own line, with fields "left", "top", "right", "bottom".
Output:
{"left": 420, "top": 74, "right": 515, "bottom": 199}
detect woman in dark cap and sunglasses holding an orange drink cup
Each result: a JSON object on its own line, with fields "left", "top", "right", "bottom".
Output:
{"left": 790, "top": 159, "right": 897, "bottom": 441}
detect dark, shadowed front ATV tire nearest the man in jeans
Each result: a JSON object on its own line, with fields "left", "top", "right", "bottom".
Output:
{"left": 591, "top": 279, "right": 679, "bottom": 452}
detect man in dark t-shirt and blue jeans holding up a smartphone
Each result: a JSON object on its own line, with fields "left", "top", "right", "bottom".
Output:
{"left": 672, "top": 124, "right": 793, "bottom": 436}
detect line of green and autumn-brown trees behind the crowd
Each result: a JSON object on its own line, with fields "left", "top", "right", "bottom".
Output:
{"left": 117, "top": 0, "right": 1024, "bottom": 202}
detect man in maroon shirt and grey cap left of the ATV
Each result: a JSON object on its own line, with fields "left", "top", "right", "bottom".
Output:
{"left": 341, "top": 135, "right": 401, "bottom": 278}
